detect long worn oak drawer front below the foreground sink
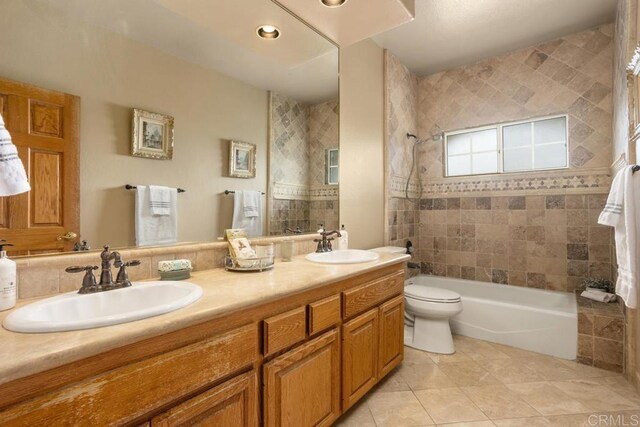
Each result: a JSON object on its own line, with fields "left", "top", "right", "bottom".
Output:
{"left": 0, "top": 324, "right": 258, "bottom": 426}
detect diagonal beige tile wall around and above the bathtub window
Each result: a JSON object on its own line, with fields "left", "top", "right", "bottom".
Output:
{"left": 418, "top": 24, "right": 613, "bottom": 180}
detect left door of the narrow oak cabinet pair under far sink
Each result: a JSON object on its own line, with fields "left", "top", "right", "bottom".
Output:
{"left": 342, "top": 307, "right": 378, "bottom": 411}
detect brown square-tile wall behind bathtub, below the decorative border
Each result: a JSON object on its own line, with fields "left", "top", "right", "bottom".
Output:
{"left": 418, "top": 194, "right": 612, "bottom": 291}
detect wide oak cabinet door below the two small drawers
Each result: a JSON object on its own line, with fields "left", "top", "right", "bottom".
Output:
{"left": 263, "top": 329, "right": 340, "bottom": 427}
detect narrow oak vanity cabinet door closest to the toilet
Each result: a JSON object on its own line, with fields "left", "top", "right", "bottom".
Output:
{"left": 378, "top": 295, "right": 404, "bottom": 378}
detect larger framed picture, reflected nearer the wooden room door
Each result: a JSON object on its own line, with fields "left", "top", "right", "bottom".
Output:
{"left": 131, "top": 108, "right": 173, "bottom": 160}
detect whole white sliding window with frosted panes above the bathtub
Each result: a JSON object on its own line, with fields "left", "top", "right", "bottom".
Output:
{"left": 445, "top": 116, "right": 568, "bottom": 176}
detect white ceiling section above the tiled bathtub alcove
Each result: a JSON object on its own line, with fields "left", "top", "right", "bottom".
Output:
{"left": 373, "top": 0, "right": 617, "bottom": 76}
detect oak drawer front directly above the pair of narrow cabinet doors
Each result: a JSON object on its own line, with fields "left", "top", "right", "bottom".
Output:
{"left": 343, "top": 271, "right": 404, "bottom": 319}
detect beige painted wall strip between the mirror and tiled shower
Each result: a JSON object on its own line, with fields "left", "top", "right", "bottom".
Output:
{"left": 340, "top": 40, "right": 385, "bottom": 248}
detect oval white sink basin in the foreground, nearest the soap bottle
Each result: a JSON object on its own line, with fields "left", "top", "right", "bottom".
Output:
{"left": 2, "top": 281, "right": 202, "bottom": 332}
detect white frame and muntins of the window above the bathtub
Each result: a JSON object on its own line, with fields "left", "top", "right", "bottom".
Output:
{"left": 443, "top": 114, "right": 571, "bottom": 178}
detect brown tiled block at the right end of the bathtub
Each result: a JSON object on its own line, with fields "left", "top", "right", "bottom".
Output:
{"left": 576, "top": 291, "right": 625, "bottom": 372}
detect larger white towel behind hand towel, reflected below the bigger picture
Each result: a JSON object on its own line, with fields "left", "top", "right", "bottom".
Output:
{"left": 135, "top": 185, "right": 178, "bottom": 246}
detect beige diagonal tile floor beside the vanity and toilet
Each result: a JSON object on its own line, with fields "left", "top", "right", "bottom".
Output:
{"left": 336, "top": 336, "right": 640, "bottom": 427}
